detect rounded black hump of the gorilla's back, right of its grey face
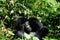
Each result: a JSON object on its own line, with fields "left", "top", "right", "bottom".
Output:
{"left": 29, "top": 17, "right": 43, "bottom": 32}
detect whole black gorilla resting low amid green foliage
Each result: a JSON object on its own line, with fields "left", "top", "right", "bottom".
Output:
{"left": 14, "top": 13, "right": 48, "bottom": 40}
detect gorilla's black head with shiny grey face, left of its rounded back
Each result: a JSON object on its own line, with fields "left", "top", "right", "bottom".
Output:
{"left": 15, "top": 16, "right": 32, "bottom": 34}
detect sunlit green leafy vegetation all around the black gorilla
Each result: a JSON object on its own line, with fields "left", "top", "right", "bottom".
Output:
{"left": 0, "top": 0, "right": 60, "bottom": 40}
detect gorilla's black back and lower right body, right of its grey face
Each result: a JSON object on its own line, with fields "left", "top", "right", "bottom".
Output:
{"left": 29, "top": 17, "right": 48, "bottom": 40}
